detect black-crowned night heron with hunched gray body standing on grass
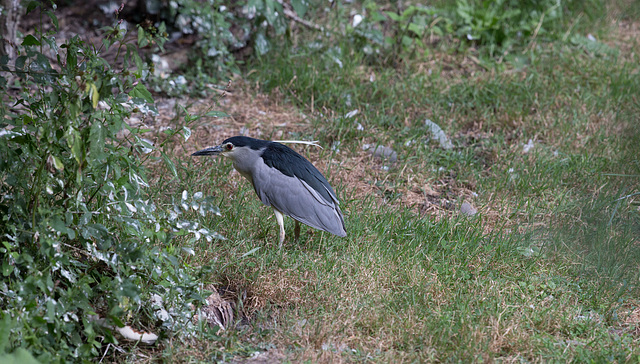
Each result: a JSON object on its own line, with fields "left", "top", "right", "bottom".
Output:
{"left": 192, "top": 136, "right": 347, "bottom": 245}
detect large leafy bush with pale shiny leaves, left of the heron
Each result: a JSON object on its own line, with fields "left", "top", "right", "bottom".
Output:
{"left": 0, "top": 2, "right": 220, "bottom": 362}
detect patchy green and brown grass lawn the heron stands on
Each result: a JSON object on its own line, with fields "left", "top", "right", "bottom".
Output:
{"left": 138, "top": 3, "right": 640, "bottom": 362}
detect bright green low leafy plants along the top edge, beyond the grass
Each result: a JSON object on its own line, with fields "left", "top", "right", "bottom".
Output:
{"left": 347, "top": 0, "right": 602, "bottom": 60}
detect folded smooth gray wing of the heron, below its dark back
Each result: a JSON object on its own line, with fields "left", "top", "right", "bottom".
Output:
{"left": 253, "top": 162, "right": 347, "bottom": 236}
